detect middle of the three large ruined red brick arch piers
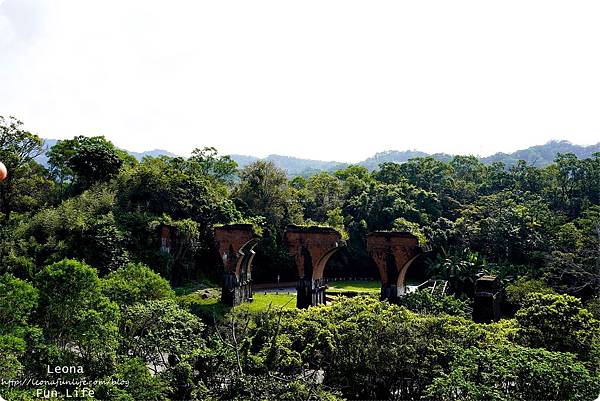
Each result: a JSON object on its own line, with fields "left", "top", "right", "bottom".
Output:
{"left": 285, "top": 225, "right": 343, "bottom": 308}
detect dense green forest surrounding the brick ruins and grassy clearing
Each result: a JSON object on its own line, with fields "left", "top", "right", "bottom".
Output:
{"left": 0, "top": 114, "right": 600, "bottom": 401}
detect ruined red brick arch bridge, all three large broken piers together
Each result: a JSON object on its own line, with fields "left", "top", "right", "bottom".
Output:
{"left": 215, "top": 224, "right": 424, "bottom": 308}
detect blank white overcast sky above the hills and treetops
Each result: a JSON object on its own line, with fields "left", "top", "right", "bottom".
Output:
{"left": 0, "top": 0, "right": 600, "bottom": 161}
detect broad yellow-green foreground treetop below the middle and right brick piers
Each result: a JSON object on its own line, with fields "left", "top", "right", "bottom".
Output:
{"left": 278, "top": 297, "right": 506, "bottom": 399}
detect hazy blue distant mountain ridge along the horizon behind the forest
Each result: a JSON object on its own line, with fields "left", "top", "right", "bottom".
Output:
{"left": 37, "top": 139, "right": 600, "bottom": 177}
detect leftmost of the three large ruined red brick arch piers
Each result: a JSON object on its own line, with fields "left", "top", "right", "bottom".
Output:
{"left": 215, "top": 224, "right": 260, "bottom": 306}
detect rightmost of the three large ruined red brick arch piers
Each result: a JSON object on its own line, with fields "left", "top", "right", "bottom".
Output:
{"left": 367, "top": 231, "right": 422, "bottom": 301}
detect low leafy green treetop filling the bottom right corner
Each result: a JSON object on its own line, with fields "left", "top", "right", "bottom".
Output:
{"left": 424, "top": 345, "right": 600, "bottom": 401}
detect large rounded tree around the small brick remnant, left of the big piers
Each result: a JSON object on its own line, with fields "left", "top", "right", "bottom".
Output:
{"left": 116, "top": 156, "right": 243, "bottom": 285}
